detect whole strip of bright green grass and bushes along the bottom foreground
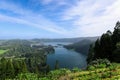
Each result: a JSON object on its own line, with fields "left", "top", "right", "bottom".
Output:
{"left": 6, "top": 63, "right": 120, "bottom": 80}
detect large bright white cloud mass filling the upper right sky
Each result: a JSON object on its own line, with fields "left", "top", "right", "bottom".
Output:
{"left": 63, "top": 0, "right": 120, "bottom": 36}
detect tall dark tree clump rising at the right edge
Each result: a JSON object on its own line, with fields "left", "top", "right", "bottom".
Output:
{"left": 87, "top": 21, "right": 120, "bottom": 63}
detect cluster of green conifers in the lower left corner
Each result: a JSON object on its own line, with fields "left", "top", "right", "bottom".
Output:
{"left": 0, "top": 57, "right": 28, "bottom": 79}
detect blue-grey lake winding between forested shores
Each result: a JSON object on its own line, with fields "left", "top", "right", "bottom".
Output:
{"left": 45, "top": 42, "right": 86, "bottom": 69}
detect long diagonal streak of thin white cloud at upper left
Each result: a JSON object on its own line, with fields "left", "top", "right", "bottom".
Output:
{"left": 0, "top": 2, "right": 67, "bottom": 35}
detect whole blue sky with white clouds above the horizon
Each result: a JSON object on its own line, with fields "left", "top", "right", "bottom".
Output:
{"left": 0, "top": 0, "right": 120, "bottom": 39}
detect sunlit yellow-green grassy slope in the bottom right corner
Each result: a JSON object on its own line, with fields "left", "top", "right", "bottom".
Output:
{"left": 59, "top": 65, "right": 120, "bottom": 80}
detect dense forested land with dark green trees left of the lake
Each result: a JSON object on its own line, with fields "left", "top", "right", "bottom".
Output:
{"left": 0, "top": 40, "right": 54, "bottom": 80}
